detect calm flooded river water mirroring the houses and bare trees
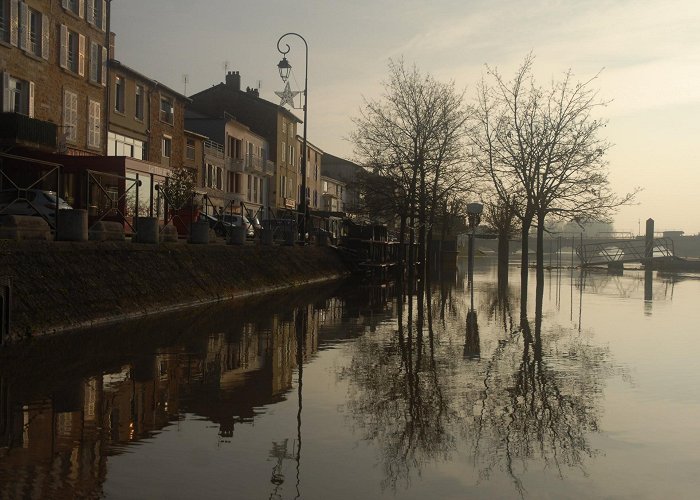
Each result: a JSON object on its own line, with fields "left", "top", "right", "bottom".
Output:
{"left": 0, "top": 259, "right": 700, "bottom": 499}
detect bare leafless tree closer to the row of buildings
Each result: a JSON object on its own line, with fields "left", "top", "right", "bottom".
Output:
{"left": 352, "top": 61, "right": 469, "bottom": 282}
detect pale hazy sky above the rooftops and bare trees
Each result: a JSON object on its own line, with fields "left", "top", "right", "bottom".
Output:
{"left": 111, "top": 0, "right": 700, "bottom": 235}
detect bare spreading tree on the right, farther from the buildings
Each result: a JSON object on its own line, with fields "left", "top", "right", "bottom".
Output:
{"left": 471, "top": 55, "right": 636, "bottom": 289}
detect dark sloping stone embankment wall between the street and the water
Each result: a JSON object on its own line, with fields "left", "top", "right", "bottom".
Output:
{"left": 0, "top": 240, "right": 348, "bottom": 340}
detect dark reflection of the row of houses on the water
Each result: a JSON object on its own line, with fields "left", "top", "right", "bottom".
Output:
{"left": 0, "top": 286, "right": 391, "bottom": 498}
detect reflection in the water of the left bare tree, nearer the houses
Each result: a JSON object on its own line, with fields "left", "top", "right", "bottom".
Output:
{"left": 340, "top": 285, "right": 457, "bottom": 489}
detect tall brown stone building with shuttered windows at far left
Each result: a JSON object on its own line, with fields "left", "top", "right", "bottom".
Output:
{"left": 0, "top": 0, "right": 110, "bottom": 155}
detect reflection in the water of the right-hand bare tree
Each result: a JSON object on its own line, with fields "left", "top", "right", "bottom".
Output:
{"left": 469, "top": 283, "right": 610, "bottom": 495}
